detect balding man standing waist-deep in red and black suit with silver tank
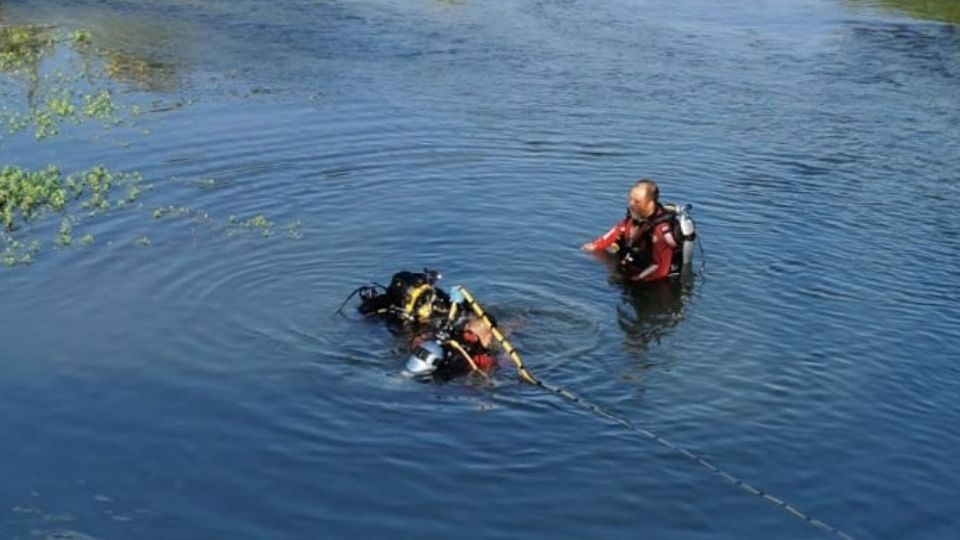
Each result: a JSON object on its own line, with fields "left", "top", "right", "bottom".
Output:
{"left": 580, "top": 179, "right": 696, "bottom": 282}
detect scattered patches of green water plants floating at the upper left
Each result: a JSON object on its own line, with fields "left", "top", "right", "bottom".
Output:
{"left": 0, "top": 25, "right": 302, "bottom": 266}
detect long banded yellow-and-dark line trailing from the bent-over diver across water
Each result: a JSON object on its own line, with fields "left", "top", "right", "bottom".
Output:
{"left": 459, "top": 287, "right": 853, "bottom": 540}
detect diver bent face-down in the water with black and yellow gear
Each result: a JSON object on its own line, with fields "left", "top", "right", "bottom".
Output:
{"left": 341, "top": 269, "right": 502, "bottom": 381}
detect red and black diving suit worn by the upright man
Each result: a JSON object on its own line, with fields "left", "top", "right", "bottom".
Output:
{"left": 593, "top": 204, "right": 681, "bottom": 281}
